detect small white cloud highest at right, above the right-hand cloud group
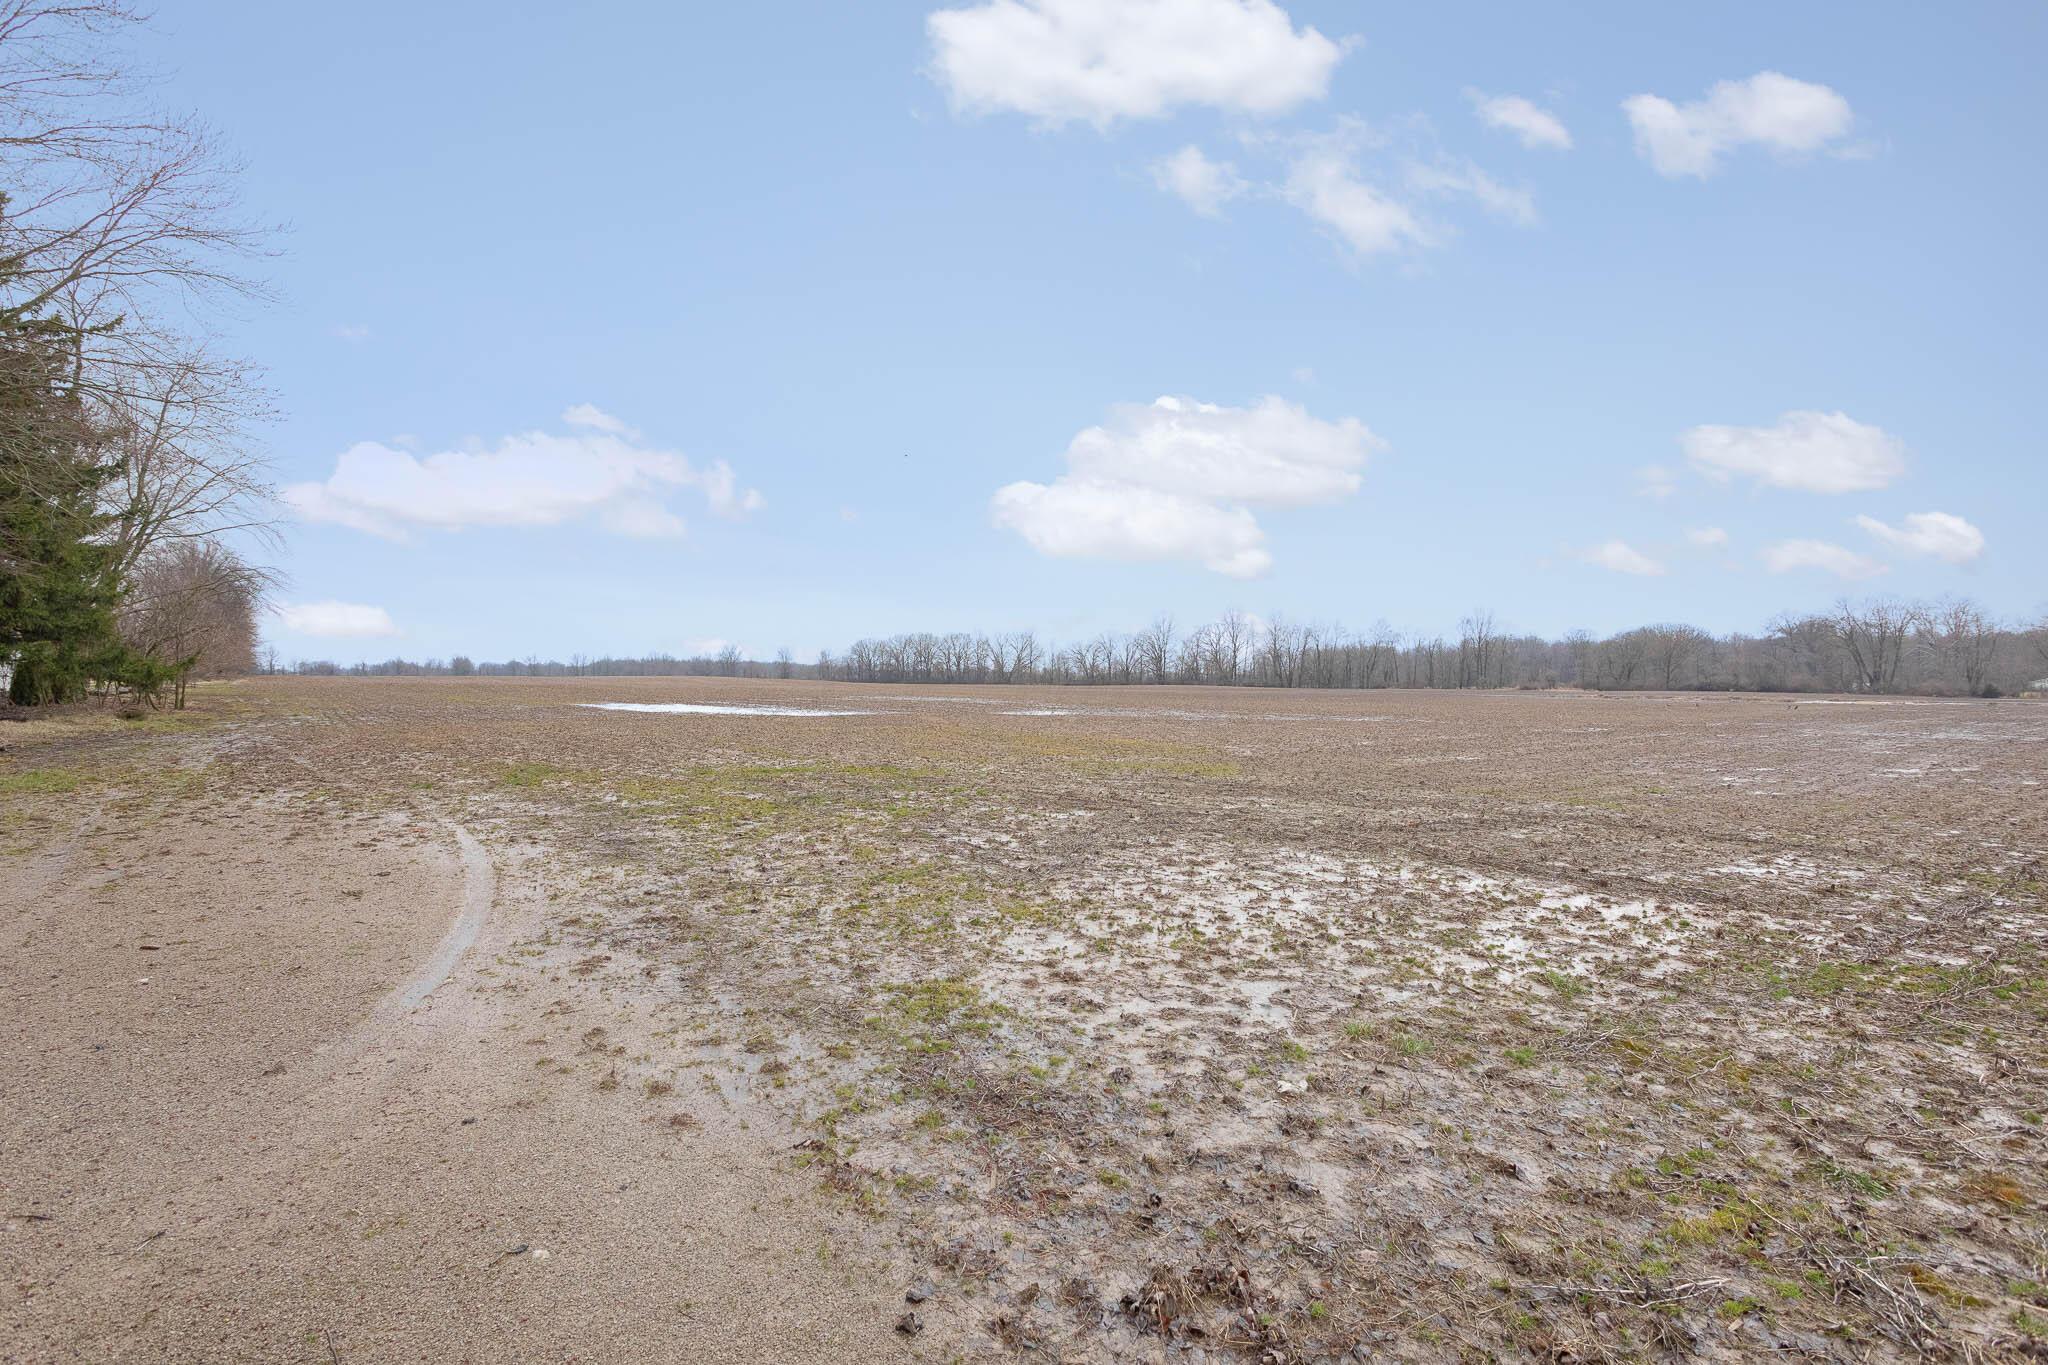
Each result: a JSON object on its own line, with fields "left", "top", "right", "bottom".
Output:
{"left": 1622, "top": 72, "right": 1855, "bottom": 178}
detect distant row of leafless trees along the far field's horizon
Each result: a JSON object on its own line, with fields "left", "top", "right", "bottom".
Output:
{"left": 280, "top": 598, "right": 2048, "bottom": 696}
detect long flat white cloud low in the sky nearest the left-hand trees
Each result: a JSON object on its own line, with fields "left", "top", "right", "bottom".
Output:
{"left": 285, "top": 403, "right": 762, "bottom": 538}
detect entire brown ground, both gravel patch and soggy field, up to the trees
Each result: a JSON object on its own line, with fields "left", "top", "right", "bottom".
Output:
{"left": 0, "top": 679, "right": 2048, "bottom": 1361}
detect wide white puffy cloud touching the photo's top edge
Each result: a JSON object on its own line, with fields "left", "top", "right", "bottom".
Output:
{"left": 924, "top": 0, "right": 1343, "bottom": 127}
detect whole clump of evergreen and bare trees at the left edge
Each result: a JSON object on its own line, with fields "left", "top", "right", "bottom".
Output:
{"left": 0, "top": 0, "right": 270, "bottom": 706}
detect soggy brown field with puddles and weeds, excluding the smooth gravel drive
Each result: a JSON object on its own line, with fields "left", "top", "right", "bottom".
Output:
{"left": 0, "top": 679, "right": 2048, "bottom": 1361}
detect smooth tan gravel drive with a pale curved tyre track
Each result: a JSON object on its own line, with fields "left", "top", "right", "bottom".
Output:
{"left": 0, "top": 749, "right": 930, "bottom": 1363}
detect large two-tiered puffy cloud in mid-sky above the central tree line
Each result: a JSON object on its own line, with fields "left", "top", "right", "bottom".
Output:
{"left": 991, "top": 397, "right": 1384, "bottom": 577}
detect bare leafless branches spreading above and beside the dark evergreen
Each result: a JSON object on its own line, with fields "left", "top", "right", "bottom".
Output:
{"left": 0, "top": 0, "right": 270, "bottom": 532}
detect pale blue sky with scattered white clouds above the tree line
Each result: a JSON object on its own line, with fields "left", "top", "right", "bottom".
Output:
{"left": 143, "top": 0, "right": 2048, "bottom": 661}
